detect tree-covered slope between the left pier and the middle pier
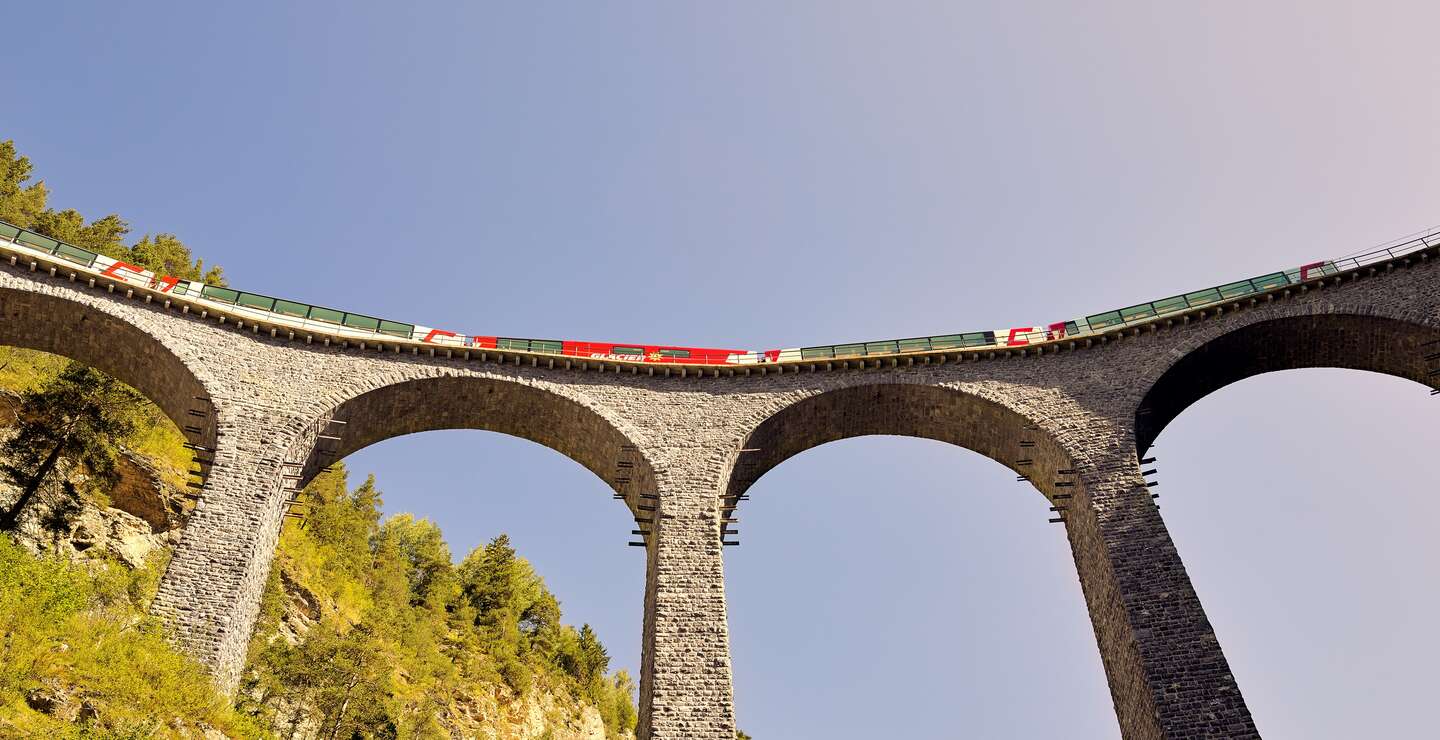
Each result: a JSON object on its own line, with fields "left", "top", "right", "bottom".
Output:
{"left": 240, "top": 465, "right": 635, "bottom": 737}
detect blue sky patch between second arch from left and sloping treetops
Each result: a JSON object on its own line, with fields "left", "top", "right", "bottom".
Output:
{"left": 334, "top": 429, "right": 645, "bottom": 682}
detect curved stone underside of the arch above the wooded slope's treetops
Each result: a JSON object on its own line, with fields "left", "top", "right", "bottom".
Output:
{"left": 290, "top": 374, "right": 654, "bottom": 505}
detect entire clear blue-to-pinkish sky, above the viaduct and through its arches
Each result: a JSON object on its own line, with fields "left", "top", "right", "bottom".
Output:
{"left": 0, "top": 1, "right": 1440, "bottom": 740}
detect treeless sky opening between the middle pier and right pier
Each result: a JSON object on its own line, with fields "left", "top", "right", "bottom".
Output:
{"left": 726, "top": 436, "right": 1117, "bottom": 740}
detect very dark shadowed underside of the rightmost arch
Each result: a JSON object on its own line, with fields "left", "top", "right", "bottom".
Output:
{"left": 1133, "top": 310, "right": 1440, "bottom": 456}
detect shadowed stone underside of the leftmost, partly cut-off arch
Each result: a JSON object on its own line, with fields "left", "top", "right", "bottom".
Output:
{"left": 0, "top": 282, "right": 215, "bottom": 448}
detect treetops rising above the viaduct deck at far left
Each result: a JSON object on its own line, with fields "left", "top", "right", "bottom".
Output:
{"left": 0, "top": 141, "right": 225, "bottom": 285}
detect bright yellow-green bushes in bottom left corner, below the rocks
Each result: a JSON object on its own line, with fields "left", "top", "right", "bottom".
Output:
{"left": 0, "top": 536, "right": 264, "bottom": 737}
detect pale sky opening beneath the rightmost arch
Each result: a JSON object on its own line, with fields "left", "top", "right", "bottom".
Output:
{"left": 1149, "top": 369, "right": 1440, "bottom": 739}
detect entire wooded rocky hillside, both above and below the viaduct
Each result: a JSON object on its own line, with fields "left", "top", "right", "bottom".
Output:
{"left": 0, "top": 141, "right": 635, "bottom": 731}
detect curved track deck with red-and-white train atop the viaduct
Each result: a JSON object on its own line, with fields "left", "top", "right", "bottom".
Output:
{"left": 0, "top": 215, "right": 1440, "bottom": 376}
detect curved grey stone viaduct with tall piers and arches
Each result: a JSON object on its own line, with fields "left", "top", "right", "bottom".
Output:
{"left": 0, "top": 231, "right": 1440, "bottom": 740}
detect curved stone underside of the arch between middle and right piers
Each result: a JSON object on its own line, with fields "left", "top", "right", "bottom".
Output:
{"left": 724, "top": 383, "right": 1070, "bottom": 501}
